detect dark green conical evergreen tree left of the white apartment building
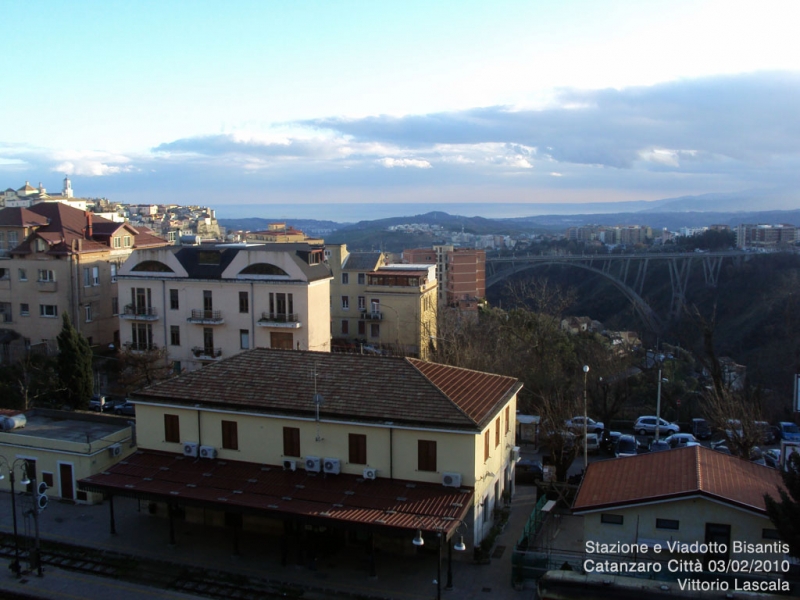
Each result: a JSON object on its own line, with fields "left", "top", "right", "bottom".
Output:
{"left": 57, "top": 313, "right": 94, "bottom": 410}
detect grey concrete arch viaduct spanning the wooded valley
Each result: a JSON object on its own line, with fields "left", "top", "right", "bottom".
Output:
{"left": 486, "top": 250, "right": 751, "bottom": 332}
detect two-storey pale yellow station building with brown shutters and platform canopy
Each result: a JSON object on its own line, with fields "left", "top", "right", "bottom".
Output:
{"left": 79, "top": 348, "right": 522, "bottom": 559}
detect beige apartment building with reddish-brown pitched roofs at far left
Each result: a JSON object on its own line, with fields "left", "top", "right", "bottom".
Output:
{"left": 0, "top": 202, "right": 166, "bottom": 347}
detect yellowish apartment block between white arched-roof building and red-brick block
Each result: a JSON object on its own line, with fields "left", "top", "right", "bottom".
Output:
{"left": 325, "top": 244, "right": 437, "bottom": 358}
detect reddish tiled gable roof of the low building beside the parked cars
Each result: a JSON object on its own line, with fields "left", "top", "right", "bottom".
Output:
{"left": 572, "top": 446, "right": 782, "bottom": 514}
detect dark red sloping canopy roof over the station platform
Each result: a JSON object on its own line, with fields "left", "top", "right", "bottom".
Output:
{"left": 78, "top": 451, "right": 474, "bottom": 534}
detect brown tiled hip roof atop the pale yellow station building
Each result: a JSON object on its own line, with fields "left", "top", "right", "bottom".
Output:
{"left": 133, "top": 348, "right": 522, "bottom": 432}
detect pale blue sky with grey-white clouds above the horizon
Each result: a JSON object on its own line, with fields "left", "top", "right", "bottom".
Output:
{"left": 0, "top": 0, "right": 800, "bottom": 216}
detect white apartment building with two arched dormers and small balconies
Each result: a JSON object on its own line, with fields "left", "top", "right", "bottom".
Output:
{"left": 118, "top": 244, "right": 331, "bottom": 371}
